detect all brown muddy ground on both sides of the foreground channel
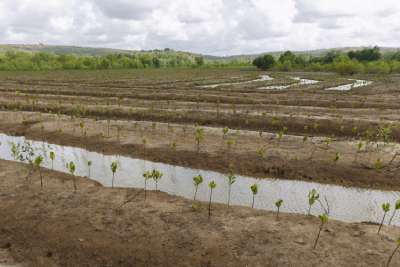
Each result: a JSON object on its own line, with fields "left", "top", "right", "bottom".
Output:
{"left": 0, "top": 69, "right": 400, "bottom": 266}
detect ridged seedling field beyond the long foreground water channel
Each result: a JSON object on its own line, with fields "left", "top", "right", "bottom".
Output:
{"left": 0, "top": 69, "right": 400, "bottom": 190}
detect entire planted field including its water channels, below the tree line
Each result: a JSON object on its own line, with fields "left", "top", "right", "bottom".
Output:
{"left": 0, "top": 69, "right": 400, "bottom": 266}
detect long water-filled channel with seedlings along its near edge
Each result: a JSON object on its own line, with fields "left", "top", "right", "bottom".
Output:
{"left": 0, "top": 134, "right": 400, "bottom": 226}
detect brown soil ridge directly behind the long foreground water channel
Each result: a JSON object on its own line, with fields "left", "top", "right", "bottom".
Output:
{"left": 0, "top": 110, "right": 400, "bottom": 190}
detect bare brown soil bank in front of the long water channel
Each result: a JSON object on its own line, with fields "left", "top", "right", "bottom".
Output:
{"left": 0, "top": 160, "right": 400, "bottom": 266}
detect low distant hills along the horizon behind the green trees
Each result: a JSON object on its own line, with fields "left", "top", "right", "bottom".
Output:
{"left": 0, "top": 44, "right": 398, "bottom": 61}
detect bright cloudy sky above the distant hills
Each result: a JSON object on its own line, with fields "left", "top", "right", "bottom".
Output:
{"left": 0, "top": 0, "right": 400, "bottom": 56}
